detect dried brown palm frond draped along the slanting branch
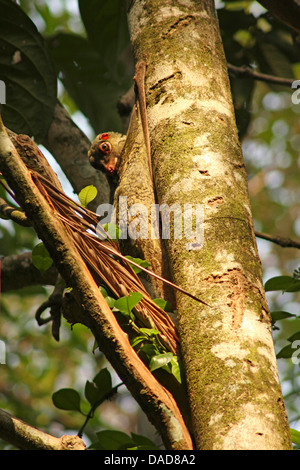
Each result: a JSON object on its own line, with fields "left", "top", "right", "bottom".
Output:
{"left": 31, "top": 170, "right": 210, "bottom": 354}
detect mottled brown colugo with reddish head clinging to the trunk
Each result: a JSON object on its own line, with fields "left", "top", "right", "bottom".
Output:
{"left": 88, "top": 102, "right": 173, "bottom": 300}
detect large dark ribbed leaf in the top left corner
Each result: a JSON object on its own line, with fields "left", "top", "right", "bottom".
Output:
{"left": 0, "top": 0, "right": 57, "bottom": 142}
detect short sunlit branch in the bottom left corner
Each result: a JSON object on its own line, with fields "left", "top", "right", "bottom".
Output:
{"left": 0, "top": 410, "right": 86, "bottom": 450}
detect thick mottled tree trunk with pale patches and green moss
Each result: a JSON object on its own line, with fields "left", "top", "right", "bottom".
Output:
{"left": 128, "top": 0, "right": 291, "bottom": 450}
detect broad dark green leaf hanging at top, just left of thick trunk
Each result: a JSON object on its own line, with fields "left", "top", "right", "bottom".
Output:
{"left": 47, "top": 0, "right": 133, "bottom": 134}
